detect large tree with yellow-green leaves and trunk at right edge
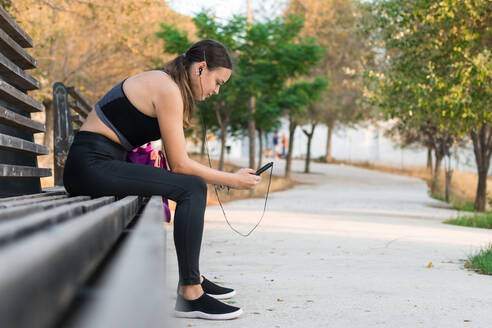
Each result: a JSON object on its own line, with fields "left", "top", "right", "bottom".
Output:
{"left": 364, "top": 0, "right": 492, "bottom": 211}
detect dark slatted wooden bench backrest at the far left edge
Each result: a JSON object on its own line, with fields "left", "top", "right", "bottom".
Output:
{"left": 0, "top": 7, "right": 51, "bottom": 197}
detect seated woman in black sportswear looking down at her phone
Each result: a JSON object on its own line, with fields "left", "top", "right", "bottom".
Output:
{"left": 63, "top": 40, "right": 261, "bottom": 319}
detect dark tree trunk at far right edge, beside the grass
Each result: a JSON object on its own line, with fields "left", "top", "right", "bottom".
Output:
{"left": 470, "top": 124, "right": 492, "bottom": 212}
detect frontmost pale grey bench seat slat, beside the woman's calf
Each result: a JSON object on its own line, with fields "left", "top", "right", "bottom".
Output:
{"left": 69, "top": 196, "right": 168, "bottom": 328}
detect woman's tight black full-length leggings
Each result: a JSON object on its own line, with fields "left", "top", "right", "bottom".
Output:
{"left": 63, "top": 131, "right": 207, "bottom": 285}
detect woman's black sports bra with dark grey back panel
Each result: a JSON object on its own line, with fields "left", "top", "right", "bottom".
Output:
{"left": 95, "top": 69, "right": 169, "bottom": 150}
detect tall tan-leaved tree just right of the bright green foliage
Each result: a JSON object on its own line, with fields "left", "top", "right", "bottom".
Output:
{"left": 287, "top": 0, "right": 373, "bottom": 163}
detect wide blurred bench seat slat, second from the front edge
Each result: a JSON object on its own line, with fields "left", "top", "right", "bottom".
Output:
{"left": 0, "top": 196, "right": 140, "bottom": 328}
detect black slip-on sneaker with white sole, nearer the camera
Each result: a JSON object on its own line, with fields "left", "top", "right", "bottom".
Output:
{"left": 174, "top": 293, "right": 243, "bottom": 320}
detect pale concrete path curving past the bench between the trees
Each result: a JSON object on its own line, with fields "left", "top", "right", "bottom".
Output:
{"left": 167, "top": 161, "right": 492, "bottom": 328}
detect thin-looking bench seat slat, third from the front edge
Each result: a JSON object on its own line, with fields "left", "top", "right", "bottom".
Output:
{"left": 0, "top": 197, "right": 114, "bottom": 246}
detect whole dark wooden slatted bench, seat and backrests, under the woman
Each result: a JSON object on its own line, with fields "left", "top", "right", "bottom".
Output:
{"left": 0, "top": 7, "right": 168, "bottom": 328}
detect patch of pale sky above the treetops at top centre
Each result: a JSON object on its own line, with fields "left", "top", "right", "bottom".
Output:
{"left": 166, "top": 0, "right": 288, "bottom": 21}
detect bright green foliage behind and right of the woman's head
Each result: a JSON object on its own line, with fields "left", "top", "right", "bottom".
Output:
{"left": 157, "top": 12, "right": 326, "bottom": 142}
